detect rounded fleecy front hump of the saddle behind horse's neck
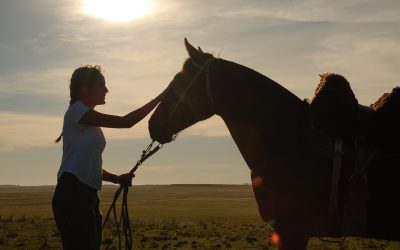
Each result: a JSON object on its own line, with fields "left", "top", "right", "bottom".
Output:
{"left": 310, "top": 73, "right": 358, "bottom": 138}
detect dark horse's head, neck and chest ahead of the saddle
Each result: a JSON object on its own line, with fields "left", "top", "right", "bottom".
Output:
{"left": 149, "top": 39, "right": 400, "bottom": 249}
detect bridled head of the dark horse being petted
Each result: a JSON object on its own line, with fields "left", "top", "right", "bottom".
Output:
{"left": 149, "top": 38, "right": 215, "bottom": 143}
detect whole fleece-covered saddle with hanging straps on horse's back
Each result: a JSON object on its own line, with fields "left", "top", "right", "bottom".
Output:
{"left": 304, "top": 73, "right": 400, "bottom": 236}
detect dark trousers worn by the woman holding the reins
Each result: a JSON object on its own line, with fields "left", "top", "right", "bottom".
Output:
{"left": 52, "top": 173, "right": 102, "bottom": 250}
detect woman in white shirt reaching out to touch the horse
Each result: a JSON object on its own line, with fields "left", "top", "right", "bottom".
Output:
{"left": 52, "top": 65, "right": 162, "bottom": 249}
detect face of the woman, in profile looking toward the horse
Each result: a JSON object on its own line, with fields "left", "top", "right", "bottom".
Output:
{"left": 81, "top": 77, "right": 108, "bottom": 108}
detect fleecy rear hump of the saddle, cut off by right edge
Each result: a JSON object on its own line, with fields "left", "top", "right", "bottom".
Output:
{"left": 369, "top": 87, "right": 400, "bottom": 147}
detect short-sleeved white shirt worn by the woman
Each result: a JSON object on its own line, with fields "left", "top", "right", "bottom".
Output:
{"left": 57, "top": 101, "right": 106, "bottom": 190}
